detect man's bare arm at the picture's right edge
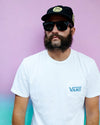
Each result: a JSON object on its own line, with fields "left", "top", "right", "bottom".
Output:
{"left": 85, "top": 96, "right": 99, "bottom": 125}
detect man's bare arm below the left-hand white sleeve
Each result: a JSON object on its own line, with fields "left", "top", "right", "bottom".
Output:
{"left": 12, "top": 95, "right": 29, "bottom": 125}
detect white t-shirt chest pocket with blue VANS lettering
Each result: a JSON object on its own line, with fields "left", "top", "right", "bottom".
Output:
{"left": 66, "top": 81, "right": 86, "bottom": 112}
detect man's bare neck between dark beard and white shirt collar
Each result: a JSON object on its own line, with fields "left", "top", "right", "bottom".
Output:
{"left": 48, "top": 48, "right": 71, "bottom": 61}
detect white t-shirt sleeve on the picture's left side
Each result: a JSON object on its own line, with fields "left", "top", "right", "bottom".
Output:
{"left": 11, "top": 61, "right": 29, "bottom": 97}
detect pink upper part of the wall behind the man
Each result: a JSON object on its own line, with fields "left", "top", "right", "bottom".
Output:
{"left": 0, "top": 0, "right": 100, "bottom": 94}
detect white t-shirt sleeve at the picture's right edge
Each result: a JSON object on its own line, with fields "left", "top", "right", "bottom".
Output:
{"left": 86, "top": 61, "right": 100, "bottom": 98}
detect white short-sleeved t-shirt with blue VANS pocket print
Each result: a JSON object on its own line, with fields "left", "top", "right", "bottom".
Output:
{"left": 11, "top": 49, "right": 100, "bottom": 125}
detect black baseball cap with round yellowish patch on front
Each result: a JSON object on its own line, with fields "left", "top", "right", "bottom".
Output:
{"left": 41, "top": 5, "right": 74, "bottom": 26}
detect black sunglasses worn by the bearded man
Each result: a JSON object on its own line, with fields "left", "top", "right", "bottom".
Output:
{"left": 43, "top": 21, "right": 73, "bottom": 31}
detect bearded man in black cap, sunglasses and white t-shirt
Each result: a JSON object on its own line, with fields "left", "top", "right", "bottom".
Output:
{"left": 11, "top": 5, "right": 100, "bottom": 125}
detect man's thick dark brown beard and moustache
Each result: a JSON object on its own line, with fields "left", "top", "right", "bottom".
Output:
{"left": 44, "top": 31, "right": 73, "bottom": 52}
